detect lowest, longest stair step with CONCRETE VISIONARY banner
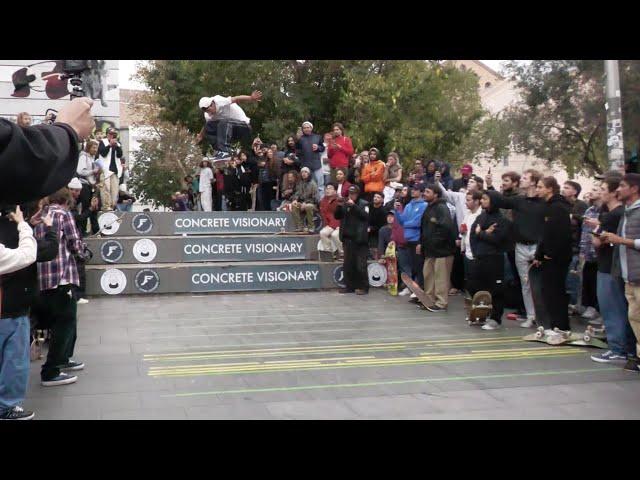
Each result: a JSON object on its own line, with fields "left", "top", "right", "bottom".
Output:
{"left": 86, "top": 261, "right": 342, "bottom": 295}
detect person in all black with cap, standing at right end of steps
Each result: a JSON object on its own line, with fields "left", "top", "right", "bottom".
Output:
{"left": 335, "top": 185, "right": 369, "bottom": 295}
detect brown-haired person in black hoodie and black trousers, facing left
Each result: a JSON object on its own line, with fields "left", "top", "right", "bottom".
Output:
{"left": 531, "top": 177, "right": 572, "bottom": 335}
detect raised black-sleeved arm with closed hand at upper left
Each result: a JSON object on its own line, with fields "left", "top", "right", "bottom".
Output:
{"left": 0, "top": 98, "right": 95, "bottom": 204}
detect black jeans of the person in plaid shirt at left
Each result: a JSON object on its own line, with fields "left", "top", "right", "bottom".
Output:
{"left": 40, "top": 285, "right": 77, "bottom": 381}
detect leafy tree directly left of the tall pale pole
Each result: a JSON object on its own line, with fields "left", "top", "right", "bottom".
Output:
{"left": 504, "top": 60, "right": 607, "bottom": 176}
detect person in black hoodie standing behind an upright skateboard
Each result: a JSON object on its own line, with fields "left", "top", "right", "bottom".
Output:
{"left": 469, "top": 193, "right": 509, "bottom": 330}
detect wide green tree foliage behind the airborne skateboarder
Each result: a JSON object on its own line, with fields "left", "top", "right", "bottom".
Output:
{"left": 139, "top": 60, "right": 485, "bottom": 171}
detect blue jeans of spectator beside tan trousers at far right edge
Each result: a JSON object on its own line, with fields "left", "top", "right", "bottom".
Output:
{"left": 597, "top": 272, "right": 636, "bottom": 356}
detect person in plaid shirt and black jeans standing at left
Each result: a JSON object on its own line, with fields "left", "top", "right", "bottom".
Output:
{"left": 35, "top": 188, "right": 84, "bottom": 387}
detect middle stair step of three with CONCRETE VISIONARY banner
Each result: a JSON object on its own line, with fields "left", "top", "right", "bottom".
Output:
{"left": 85, "top": 235, "right": 320, "bottom": 265}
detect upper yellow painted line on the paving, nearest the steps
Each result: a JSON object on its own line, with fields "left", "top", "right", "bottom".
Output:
{"left": 144, "top": 336, "right": 522, "bottom": 361}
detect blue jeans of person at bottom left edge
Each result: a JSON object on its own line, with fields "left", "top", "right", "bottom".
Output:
{"left": 0, "top": 316, "right": 31, "bottom": 412}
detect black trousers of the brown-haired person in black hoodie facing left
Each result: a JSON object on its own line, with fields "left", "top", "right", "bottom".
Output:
{"left": 529, "top": 260, "right": 570, "bottom": 330}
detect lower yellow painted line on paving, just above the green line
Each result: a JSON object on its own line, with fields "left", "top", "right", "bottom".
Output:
{"left": 149, "top": 349, "right": 583, "bottom": 377}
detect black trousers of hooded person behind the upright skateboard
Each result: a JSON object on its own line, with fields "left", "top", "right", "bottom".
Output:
{"left": 468, "top": 254, "right": 504, "bottom": 324}
